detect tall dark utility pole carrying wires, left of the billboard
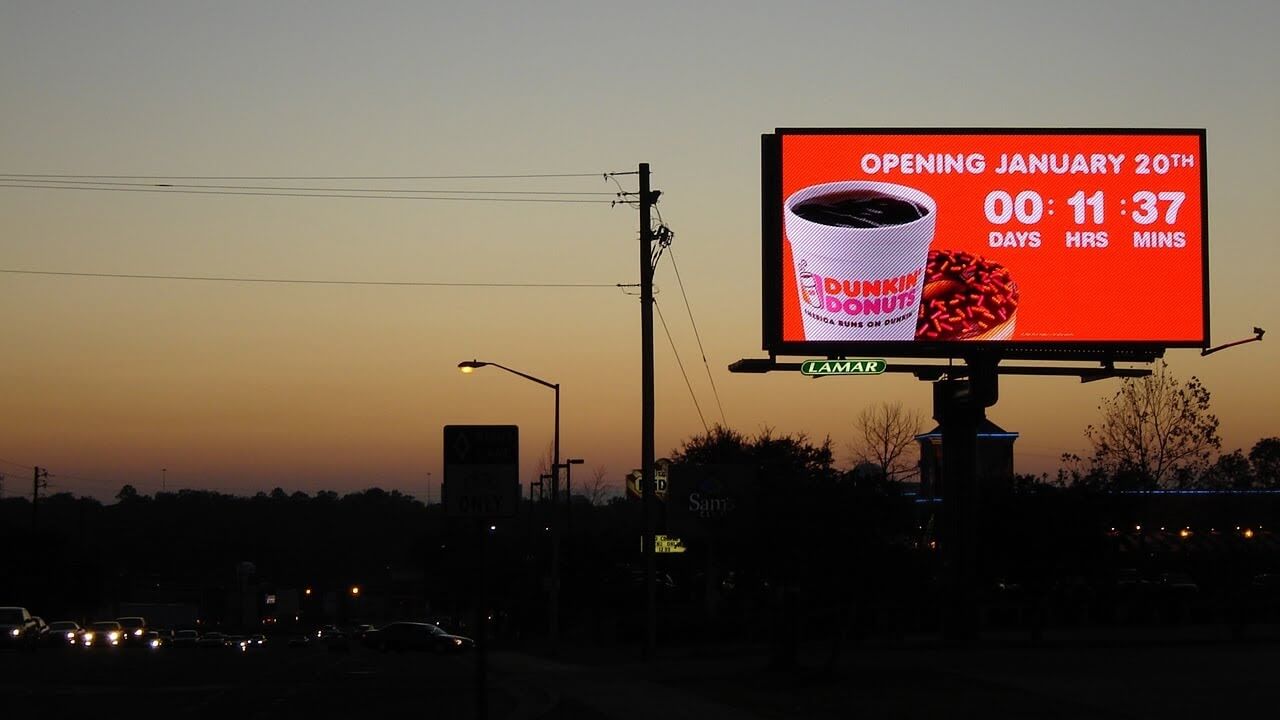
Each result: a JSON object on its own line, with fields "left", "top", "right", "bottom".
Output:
{"left": 640, "top": 163, "right": 658, "bottom": 661}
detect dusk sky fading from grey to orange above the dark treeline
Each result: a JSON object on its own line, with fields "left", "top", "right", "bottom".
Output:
{"left": 0, "top": 0, "right": 1280, "bottom": 497}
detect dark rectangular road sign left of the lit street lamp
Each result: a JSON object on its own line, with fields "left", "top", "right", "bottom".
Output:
{"left": 443, "top": 425, "right": 520, "bottom": 518}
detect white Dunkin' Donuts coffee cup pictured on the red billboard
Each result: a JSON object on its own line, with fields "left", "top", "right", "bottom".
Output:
{"left": 783, "top": 181, "right": 938, "bottom": 341}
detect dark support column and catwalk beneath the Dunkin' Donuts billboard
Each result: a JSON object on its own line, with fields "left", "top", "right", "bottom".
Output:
{"left": 728, "top": 350, "right": 1151, "bottom": 647}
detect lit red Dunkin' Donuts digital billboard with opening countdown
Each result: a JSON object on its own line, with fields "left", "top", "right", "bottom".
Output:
{"left": 762, "top": 129, "right": 1208, "bottom": 356}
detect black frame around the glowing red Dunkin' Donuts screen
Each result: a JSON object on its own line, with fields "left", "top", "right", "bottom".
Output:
{"left": 760, "top": 127, "right": 1211, "bottom": 363}
